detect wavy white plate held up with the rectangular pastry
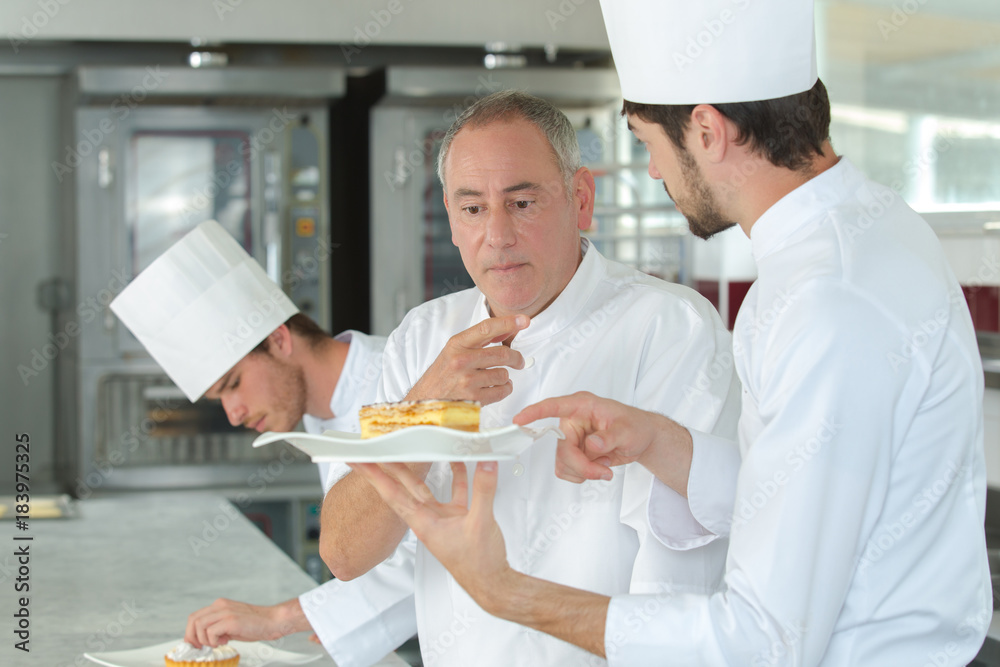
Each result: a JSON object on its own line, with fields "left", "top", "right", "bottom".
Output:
{"left": 253, "top": 425, "right": 562, "bottom": 463}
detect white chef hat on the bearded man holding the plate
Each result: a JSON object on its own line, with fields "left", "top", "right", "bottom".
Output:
{"left": 601, "top": 0, "right": 817, "bottom": 104}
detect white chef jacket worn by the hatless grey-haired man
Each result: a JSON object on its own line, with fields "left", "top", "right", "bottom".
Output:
{"left": 379, "top": 240, "right": 739, "bottom": 667}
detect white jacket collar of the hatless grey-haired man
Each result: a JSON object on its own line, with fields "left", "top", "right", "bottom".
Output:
{"left": 469, "top": 238, "right": 605, "bottom": 349}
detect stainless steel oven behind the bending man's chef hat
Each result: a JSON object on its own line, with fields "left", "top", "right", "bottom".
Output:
{"left": 60, "top": 67, "right": 345, "bottom": 495}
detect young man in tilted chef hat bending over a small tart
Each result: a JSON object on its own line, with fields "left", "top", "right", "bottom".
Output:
{"left": 111, "top": 221, "right": 416, "bottom": 667}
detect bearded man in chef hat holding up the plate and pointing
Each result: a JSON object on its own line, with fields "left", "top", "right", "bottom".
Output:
{"left": 354, "top": 0, "right": 992, "bottom": 667}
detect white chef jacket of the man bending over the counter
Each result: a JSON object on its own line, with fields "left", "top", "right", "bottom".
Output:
{"left": 299, "top": 331, "right": 417, "bottom": 667}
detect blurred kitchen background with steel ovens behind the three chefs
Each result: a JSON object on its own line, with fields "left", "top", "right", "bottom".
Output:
{"left": 0, "top": 0, "right": 1000, "bottom": 620}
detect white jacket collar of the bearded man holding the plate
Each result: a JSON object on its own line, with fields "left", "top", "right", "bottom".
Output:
{"left": 750, "top": 157, "right": 864, "bottom": 262}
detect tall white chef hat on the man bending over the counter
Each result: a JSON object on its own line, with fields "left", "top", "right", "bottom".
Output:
{"left": 111, "top": 220, "right": 299, "bottom": 401}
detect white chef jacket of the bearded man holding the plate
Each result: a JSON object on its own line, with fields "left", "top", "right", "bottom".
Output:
{"left": 605, "top": 158, "right": 992, "bottom": 667}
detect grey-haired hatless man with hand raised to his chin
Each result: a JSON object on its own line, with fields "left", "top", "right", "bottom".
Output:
{"left": 321, "top": 91, "right": 738, "bottom": 667}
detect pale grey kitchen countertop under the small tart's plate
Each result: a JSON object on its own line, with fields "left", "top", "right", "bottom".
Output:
{"left": 0, "top": 491, "right": 406, "bottom": 667}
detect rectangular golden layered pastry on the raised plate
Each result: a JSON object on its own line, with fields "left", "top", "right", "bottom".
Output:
{"left": 358, "top": 399, "right": 482, "bottom": 439}
